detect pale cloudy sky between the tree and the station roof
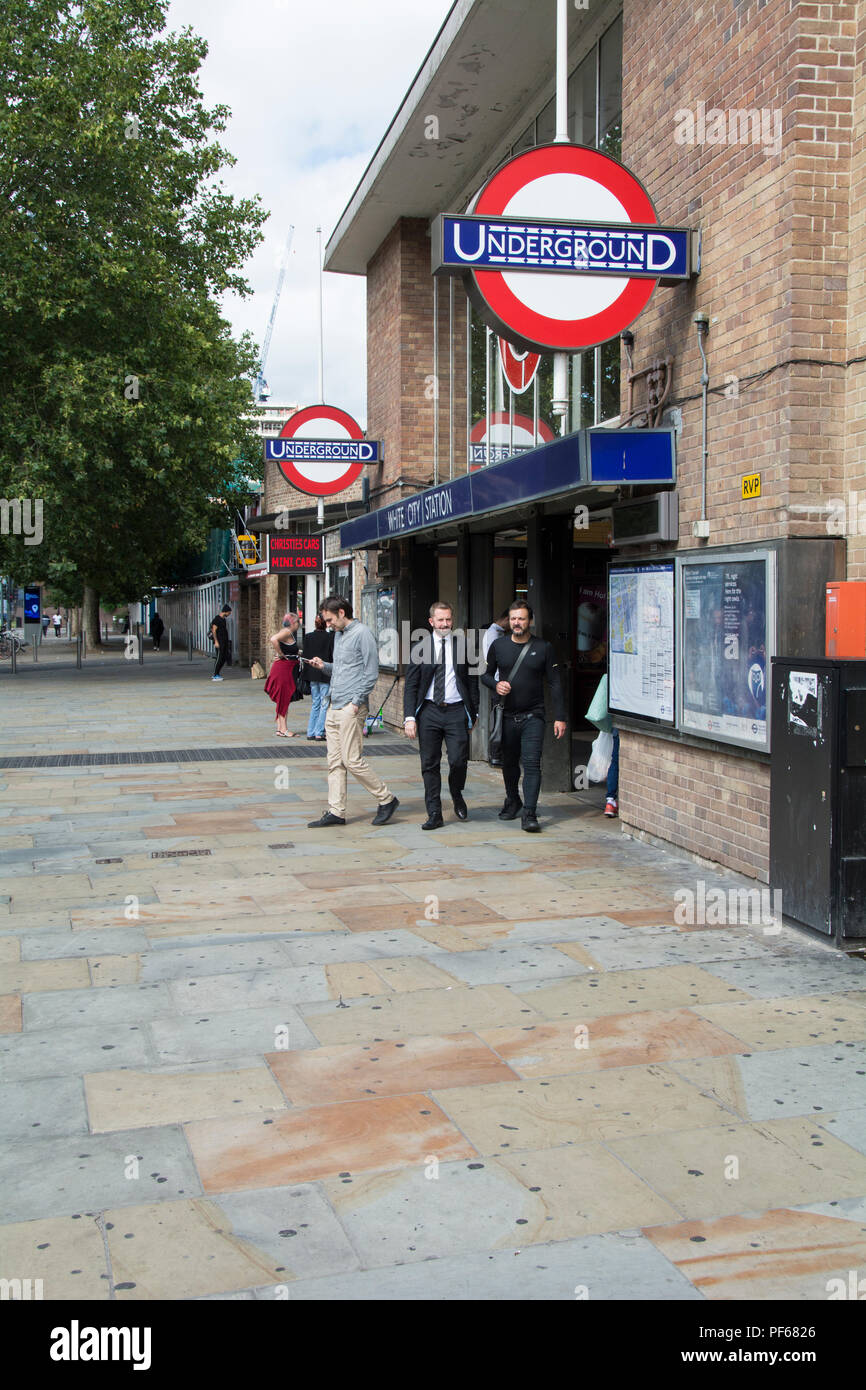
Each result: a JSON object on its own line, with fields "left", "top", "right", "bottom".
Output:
{"left": 168, "top": 0, "right": 452, "bottom": 425}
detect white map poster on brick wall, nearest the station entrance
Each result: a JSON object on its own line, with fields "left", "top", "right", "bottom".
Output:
{"left": 607, "top": 560, "right": 674, "bottom": 723}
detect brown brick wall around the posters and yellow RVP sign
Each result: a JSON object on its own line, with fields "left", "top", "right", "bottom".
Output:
{"left": 620, "top": 0, "right": 866, "bottom": 878}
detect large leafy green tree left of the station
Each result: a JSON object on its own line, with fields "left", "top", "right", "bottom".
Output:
{"left": 0, "top": 0, "right": 267, "bottom": 641}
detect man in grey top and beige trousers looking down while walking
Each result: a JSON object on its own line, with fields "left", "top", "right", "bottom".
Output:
{"left": 309, "top": 596, "right": 399, "bottom": 830}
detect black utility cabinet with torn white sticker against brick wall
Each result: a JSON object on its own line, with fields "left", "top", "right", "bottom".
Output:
{"left": 770, "top": 657, "right": 866, "bottom": 945}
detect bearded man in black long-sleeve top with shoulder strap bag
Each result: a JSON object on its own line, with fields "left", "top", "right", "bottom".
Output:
{"left": 481, "top": 599, "right": 566, "bottom": 831}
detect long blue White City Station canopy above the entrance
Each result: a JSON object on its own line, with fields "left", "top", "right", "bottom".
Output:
{"left": 339, "top": 430, "right": 677, "bottom": 550}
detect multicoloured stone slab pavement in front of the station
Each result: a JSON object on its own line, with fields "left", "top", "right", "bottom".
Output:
{"left": 0, "top": 653, "right": 866, "bottom": 1300}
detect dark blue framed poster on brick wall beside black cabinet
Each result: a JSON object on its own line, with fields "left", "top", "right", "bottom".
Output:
{"left": 680, "top": 557, "right": 770, "bottom": 748}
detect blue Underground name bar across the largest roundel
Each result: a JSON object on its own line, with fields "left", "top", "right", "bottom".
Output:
{"left": 432, "top": 214, "right": 692, "bottom": 279}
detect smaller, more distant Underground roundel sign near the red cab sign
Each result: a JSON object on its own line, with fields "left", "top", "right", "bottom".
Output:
{"left": 272, "top": 406, "right": 369, "bottom": 498}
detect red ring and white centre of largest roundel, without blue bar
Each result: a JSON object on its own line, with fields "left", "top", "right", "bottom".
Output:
{"left": 467, "top": 145, "right": 659, "bottom": 353}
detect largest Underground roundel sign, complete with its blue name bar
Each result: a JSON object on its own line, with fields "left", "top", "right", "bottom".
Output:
{"left": 434, "top": 143, "right": 694, "bottom": 353}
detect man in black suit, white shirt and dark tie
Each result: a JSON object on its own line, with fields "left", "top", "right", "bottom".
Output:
{"left": 403, "top": 602, "right": 478, "bottom": 830}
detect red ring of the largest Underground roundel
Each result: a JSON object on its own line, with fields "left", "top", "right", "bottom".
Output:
{"left": 468, "top": 145, "right": 659, "bottom": 352}
